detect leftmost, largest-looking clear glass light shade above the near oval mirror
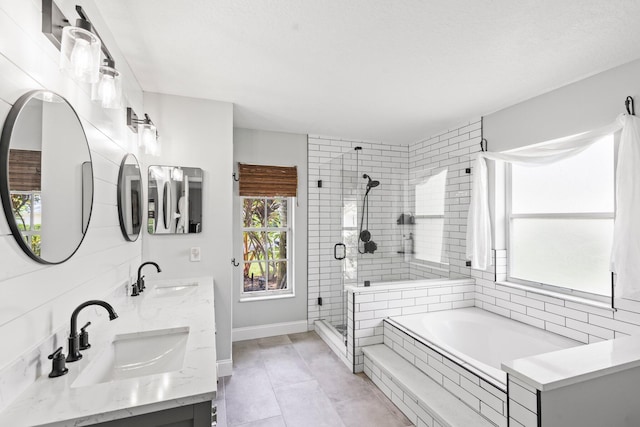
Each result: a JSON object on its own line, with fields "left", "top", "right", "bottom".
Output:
{"left": 60, "top": 26, "right": 101, "bottom": 83}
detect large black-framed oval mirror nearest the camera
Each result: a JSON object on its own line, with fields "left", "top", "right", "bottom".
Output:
{"left": 0, "top": 90, "right": 93, "bottom": 264}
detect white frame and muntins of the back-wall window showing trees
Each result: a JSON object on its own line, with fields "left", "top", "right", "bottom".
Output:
{"left": 239, "top": 196, "right": 296, "bottom": 301}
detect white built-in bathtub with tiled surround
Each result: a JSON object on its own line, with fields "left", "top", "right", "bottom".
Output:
{"left": 386, "top": 307, "right": 583, "bottom": 390}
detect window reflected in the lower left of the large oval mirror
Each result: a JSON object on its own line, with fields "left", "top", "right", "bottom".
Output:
{"left": 11, "top": 191, "right": 42, "bottom": 256}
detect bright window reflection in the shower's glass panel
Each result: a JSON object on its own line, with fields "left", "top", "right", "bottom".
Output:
{"left": 412, "top": 169, "right": 448, "bottom": 264}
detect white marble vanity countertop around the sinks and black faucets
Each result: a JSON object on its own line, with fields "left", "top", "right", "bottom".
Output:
{"left": 0, "top": 277, "right": 217, "bottom": 427}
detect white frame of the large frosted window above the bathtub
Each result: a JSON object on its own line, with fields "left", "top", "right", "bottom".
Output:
{"left": 504, "top": 136, "right": 620, "bottom": 302}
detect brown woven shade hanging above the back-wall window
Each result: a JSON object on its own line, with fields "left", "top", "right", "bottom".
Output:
{"left": 238, "top": 163, "right": 298, "bottom": 197}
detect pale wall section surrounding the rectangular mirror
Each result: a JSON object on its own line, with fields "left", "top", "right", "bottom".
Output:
{"left": 139, "top": 93, "right": 233, "bottom": 360}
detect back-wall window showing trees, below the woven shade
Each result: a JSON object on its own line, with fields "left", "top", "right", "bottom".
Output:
{"left": 242, "top": 197, "right": 293, "bottom": 296}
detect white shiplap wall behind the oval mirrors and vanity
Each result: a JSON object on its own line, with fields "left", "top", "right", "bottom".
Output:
{"left": 0, "top": 0, "right": 142, "bottom": 408}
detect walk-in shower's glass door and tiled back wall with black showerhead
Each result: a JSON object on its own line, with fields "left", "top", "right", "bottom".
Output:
{"left": 310, "top": 148, "right": 407, "bottom": 348}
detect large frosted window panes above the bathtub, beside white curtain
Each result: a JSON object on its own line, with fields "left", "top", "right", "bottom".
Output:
{"left": 507, "top": 135, "right": 615, "bottom": 295}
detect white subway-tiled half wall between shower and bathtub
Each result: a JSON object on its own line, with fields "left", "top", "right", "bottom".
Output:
{"left": 347, "top": 279, "right": 475, "bottom": 372}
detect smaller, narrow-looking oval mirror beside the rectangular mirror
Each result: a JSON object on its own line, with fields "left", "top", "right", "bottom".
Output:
{"left": 118, "top": 154, "right": 142, "bottom": 242}
